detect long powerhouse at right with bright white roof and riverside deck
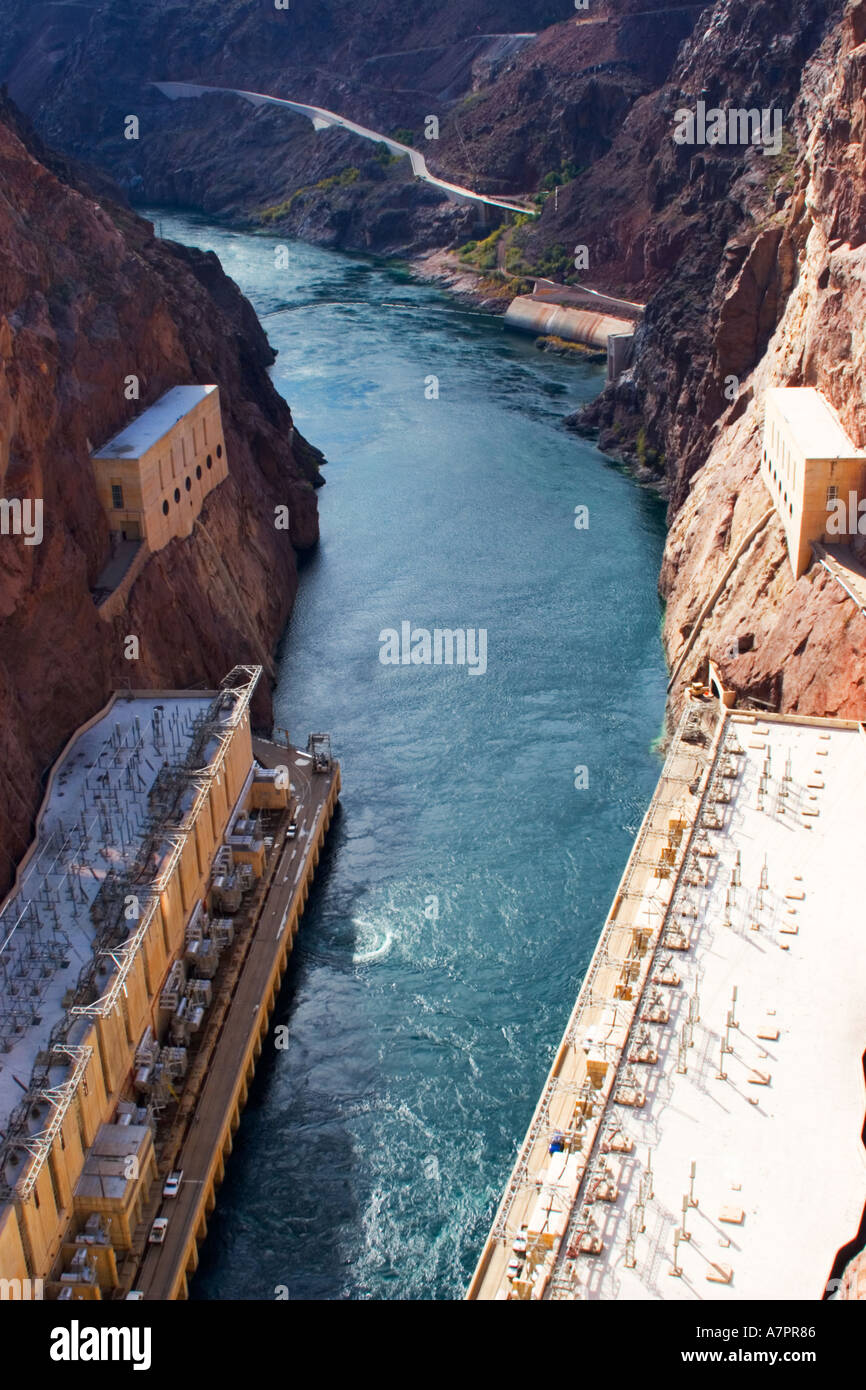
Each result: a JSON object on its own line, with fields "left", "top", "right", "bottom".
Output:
{"left": 467, "top": 691, "right": 866, "bottom": 1301}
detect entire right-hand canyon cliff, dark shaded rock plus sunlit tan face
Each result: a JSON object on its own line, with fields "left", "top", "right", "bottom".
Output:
{"left": 558, "top": 0, "right": 866, "bottom": 719}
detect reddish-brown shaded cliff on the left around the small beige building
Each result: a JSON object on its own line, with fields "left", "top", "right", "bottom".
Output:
{"left": 0, "top": 107, "right": 318, "bottom": 888}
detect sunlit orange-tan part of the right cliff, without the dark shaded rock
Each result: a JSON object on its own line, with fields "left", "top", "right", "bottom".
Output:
{"left": 662, "top": 11, "right": 866, "bottom": 719}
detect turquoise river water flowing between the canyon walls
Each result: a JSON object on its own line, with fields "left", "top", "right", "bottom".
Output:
{"left": 150, "top": 214, "right": 666, "bottom": 1300}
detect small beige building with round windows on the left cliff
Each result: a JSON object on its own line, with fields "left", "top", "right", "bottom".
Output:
{"left": 92, "top": 385, "right": 228, "bottom": 550}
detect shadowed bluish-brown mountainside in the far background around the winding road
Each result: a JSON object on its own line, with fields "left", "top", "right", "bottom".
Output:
{"left": 0, "top": 0, "right": 701, "bottom": 253}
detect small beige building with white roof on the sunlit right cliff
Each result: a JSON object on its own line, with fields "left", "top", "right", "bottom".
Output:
{"left": 760, "top": 386, "right": 866, "bottom": 580}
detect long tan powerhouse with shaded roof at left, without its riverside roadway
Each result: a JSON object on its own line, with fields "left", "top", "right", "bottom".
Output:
{"left": 0, "top": 667, "right": 291, "bottom": 1298}
